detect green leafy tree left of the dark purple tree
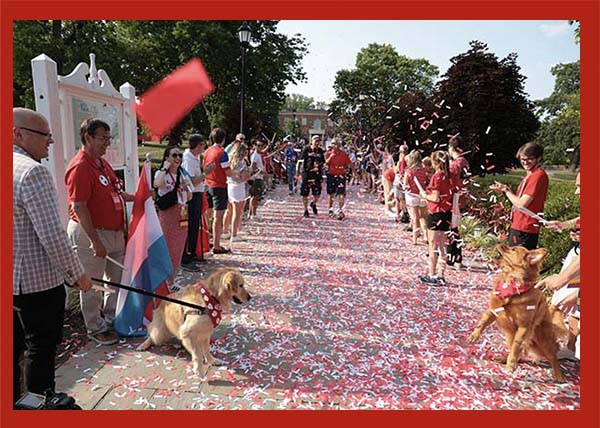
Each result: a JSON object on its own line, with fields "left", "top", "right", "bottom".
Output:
{"left": 329, "top": 43, "right": 438, "bottom": 146}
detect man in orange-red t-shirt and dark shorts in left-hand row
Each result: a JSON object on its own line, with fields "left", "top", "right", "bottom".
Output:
{"left": 204, "top": 128, "right": 233, "bottom": 254}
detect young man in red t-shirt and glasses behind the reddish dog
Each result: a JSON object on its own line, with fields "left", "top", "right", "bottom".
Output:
{"left": 490, "top": 143, "right": 548, "bottom": 250}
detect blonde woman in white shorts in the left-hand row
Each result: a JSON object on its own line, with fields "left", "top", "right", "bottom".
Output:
{"left": 227, "top": 143, "right": 250, "bottom": 242}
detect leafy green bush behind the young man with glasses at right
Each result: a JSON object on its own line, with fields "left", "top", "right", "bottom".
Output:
{"left": 461, "top": 175, "right": 579, "bottom": 273}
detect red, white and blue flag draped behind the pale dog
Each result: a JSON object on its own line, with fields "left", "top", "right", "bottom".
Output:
{"left": 115, "top": 161, "right": 173, "bottom": 336}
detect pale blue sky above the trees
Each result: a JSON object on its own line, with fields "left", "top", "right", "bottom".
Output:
{"left": 278, "top": 20, "right": 579, "bottom": 102}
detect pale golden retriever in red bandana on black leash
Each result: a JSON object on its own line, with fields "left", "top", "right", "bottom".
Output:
{"left": 137, "top": 268, "right": 251, "bottom": 377}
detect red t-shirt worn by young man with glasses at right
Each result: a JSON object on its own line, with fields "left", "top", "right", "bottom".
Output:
{"left": 510, "top": 167, "right": 548, "bottom": 234}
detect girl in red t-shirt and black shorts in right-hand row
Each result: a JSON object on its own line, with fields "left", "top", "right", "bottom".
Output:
{"left": 419, "top": 151, "right": 453, "bottom": 285}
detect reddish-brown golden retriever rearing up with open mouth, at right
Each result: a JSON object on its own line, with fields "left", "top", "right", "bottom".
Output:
{"left": 468, "top": 244, "right": 568, "bottom": 382}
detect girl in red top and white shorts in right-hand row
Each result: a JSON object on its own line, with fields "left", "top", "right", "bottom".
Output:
{"left": 404, "top": 150, "right": 431, "bottom": 245}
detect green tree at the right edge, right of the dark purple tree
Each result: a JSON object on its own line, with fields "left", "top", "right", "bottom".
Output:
{"left": 536, "top": 61, "right": 580, "bottom": 168}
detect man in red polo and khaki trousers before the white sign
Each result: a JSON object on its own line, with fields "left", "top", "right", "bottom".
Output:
{"left": 65, "top": 118, "right": 133, "bottom": 345}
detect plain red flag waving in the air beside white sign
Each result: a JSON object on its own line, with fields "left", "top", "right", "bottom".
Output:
{"left": 136, "top": 58, "right": 214, "bottom": 136}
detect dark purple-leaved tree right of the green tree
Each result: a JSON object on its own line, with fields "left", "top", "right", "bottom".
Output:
{"left": 434, "top": 41, "right": 539, "bottom": 174}
